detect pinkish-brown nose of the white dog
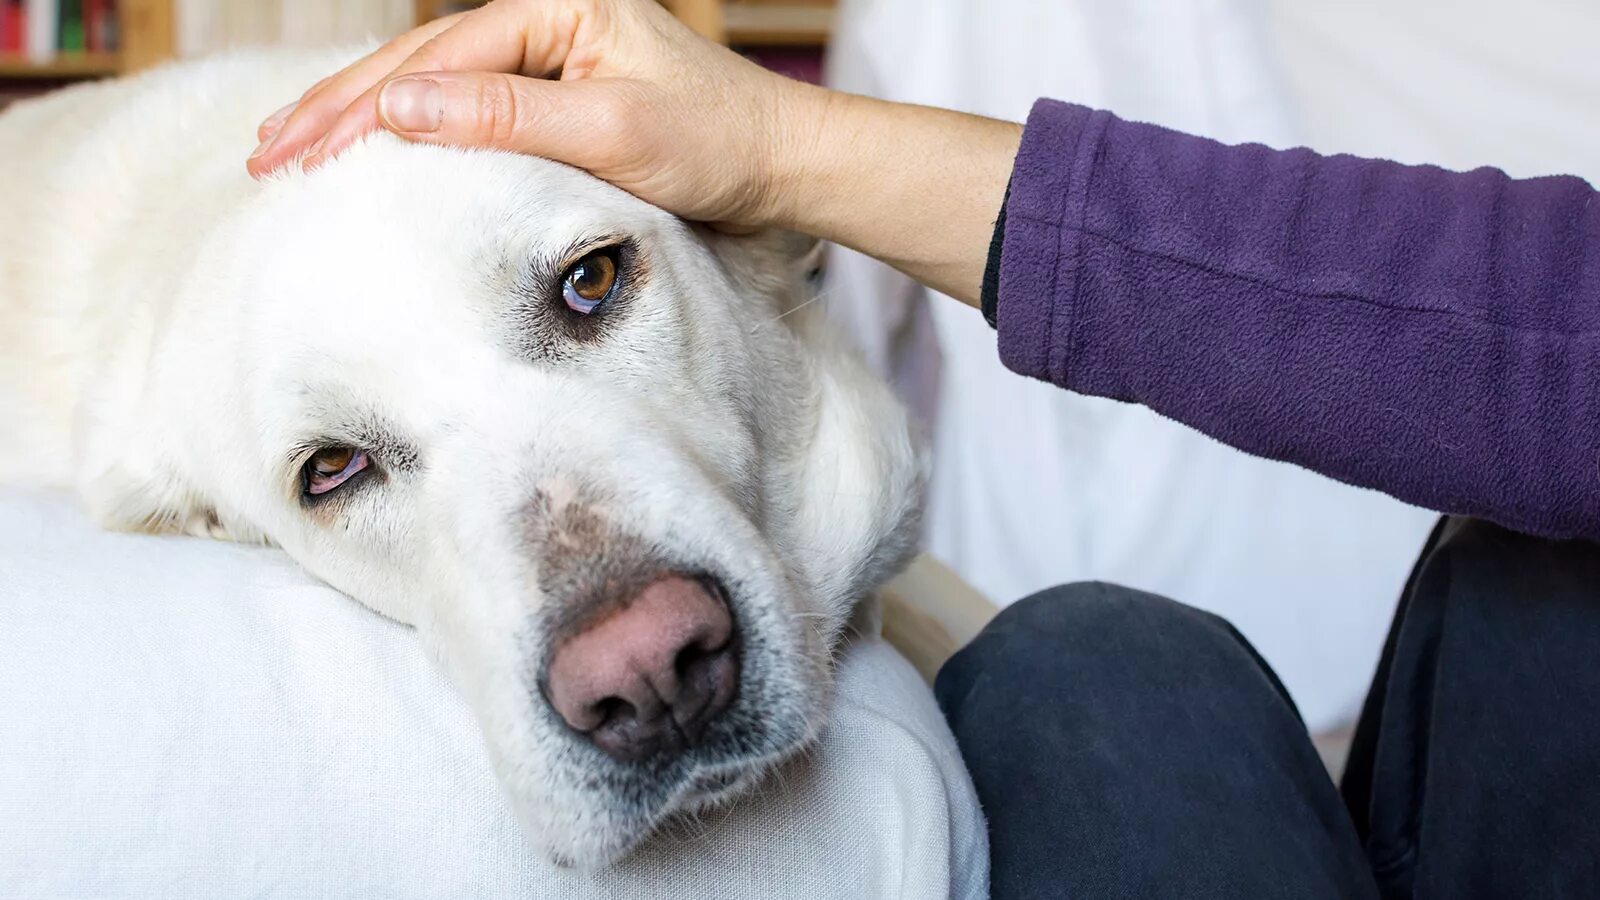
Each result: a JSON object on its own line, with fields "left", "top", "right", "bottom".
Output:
{"left": 546, "top": 575, "right": 739, "bottom": 761}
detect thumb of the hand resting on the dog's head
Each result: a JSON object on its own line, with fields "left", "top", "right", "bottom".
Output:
{"left": 378, "top": 72, "right": 627, "bottom": 168}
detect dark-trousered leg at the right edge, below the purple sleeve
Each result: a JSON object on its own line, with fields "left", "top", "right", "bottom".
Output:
{"left": 1342, "top": 520, "right": 1600, "bottom": 900}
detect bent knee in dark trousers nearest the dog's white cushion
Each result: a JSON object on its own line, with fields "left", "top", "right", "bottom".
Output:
{"left": 936, "top": 585, "right": 1376, "bottom": 900}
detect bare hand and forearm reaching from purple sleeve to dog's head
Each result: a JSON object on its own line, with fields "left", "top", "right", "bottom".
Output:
{"left": 248, "top": 0, "right": 1022, "bottom": 306}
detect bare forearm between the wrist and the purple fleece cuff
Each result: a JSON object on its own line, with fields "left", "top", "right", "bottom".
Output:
{"left": 771, "top": 86, "right": 1022, "bottom": 306}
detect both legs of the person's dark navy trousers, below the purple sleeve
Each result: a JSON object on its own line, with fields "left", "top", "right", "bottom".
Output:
{"left": 938, "top": 520, "right": 1600, "bottom": 900}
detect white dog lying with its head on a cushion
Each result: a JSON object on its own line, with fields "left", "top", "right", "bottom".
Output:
{"left": 0, "top": 53, "right": 920, "bottom": 866}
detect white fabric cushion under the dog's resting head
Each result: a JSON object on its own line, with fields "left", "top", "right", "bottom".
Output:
{"left": 0, "top": 488, "right": 989, "bottom": 900}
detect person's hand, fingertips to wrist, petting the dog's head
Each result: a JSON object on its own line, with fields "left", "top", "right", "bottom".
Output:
{"left": 248, "top": 0, "right": 822, "bottom": 227}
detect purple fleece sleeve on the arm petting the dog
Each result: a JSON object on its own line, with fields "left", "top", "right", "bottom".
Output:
{"left": 997, "top": 101, "right": 1600, "bottom": 538}
